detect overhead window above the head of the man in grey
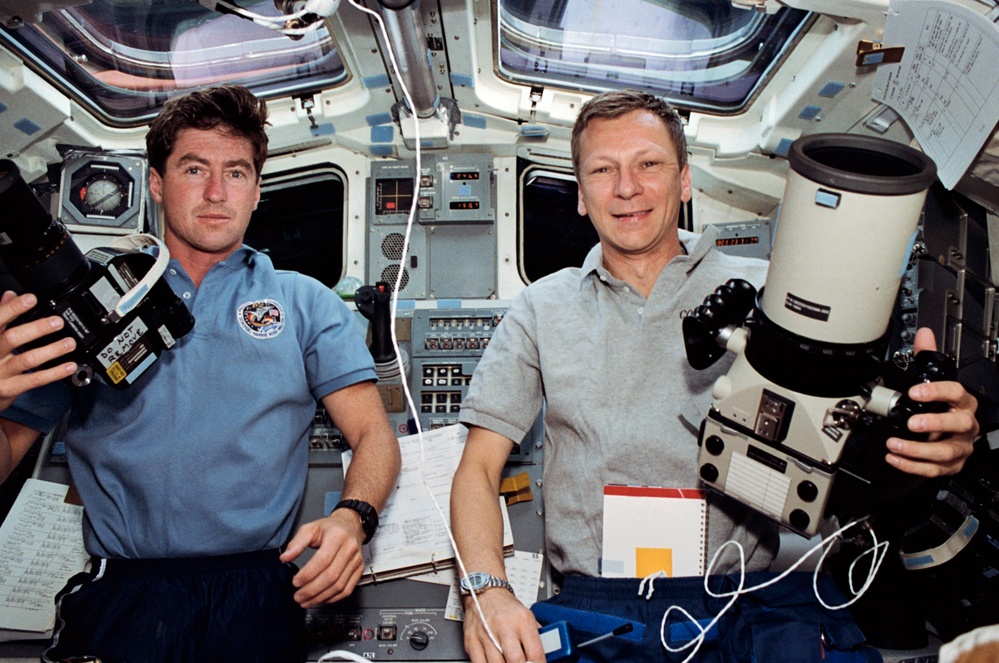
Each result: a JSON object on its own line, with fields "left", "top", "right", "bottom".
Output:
{"left": 498, "top": 0, "right": 810, "bottom": 112}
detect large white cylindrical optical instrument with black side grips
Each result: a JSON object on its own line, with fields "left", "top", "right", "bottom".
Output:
{"left": 683, "top": 134, "right": 940, "bottom": 537}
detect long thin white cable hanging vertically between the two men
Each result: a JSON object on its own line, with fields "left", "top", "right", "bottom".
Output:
{"left": 349, "top": 0, "right": 516, "bottom": 654}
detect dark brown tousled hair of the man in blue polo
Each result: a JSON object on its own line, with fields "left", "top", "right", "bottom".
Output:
{"left": 146, "top": 85, "right": 267, "bottom": 178}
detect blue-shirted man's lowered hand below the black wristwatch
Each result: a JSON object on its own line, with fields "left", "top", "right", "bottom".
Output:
{"left": 281, "top": 509, "right": 364, "bottom": 608}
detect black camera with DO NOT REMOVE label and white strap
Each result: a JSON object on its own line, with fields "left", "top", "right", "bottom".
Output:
{"left": 0, "top": 159, "right": 194, "bottom": 389}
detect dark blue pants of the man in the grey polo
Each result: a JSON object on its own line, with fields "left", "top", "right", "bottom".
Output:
{"left": 531, "top": 573, "right": 881, "bottom": 663}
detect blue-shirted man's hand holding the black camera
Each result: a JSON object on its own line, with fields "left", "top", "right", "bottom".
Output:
{"left": 0, "top": 291, "right": 77, "bottom": 410}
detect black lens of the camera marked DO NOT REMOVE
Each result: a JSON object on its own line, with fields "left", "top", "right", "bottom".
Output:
{"left": 0, "top": 159, "right": 90, "bottom": 299}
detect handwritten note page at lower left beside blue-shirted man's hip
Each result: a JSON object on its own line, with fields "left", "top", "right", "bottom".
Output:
{"left": 0, "top": 479, "right": 88, "bottom": 637}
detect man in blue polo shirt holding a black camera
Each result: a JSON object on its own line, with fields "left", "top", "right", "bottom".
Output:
{"left": 0, "top": 86, "right": 400, "bottom": 663}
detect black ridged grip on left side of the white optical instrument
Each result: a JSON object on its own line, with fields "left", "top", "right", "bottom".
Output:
{"left": 683, "top": 279, "right": 756, "bottom": 370}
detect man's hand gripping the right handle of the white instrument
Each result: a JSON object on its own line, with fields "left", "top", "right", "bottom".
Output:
{"left": 885, "top": 328, "right": 978, "bottom": 477}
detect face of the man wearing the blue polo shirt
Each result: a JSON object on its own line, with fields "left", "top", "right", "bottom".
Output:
{"left": 149, "top": 129, "right": 260, "bottom": 260}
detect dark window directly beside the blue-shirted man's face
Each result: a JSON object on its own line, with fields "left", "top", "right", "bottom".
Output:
{"left": 244, "top": 168, "right": 344, "bottom": 288}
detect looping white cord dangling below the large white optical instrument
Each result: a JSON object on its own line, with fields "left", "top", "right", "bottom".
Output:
{"left": 659, "top": 519, "right": 888, "bottom": 663}
